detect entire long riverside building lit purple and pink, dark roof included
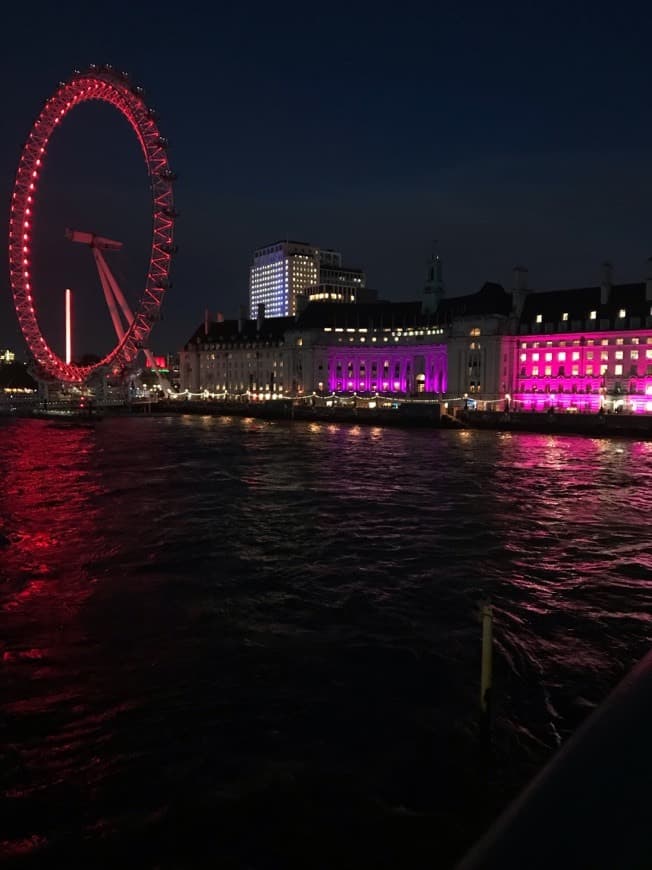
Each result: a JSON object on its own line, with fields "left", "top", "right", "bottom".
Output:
{"left": 180, "top": 256, "right": 652, "bottom": 413}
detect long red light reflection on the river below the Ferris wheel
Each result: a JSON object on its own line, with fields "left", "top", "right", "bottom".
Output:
{"left": 0, "top": 420, "right": 112, "bottom": 859}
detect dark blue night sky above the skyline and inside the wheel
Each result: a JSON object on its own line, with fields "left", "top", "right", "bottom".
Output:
{"left": 0, "top": 2, "right": 652, "bottom": 354}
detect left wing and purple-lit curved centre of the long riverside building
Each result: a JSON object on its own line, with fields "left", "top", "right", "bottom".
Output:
{"left": 180, "top": 302, "right": 447, "bottom": 397}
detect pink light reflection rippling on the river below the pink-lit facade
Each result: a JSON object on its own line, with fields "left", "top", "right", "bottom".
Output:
{"left": 484, "top": 434, "right": 652, "bottom": 716}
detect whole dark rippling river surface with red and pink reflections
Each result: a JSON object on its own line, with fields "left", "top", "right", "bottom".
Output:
{"left": 0, "top": 417, "right": 652, "bottom": 870}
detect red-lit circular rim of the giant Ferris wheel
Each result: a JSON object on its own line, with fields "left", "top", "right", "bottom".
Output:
{"left": 9, "top": 66, "right": 175, "bottom": 383}
